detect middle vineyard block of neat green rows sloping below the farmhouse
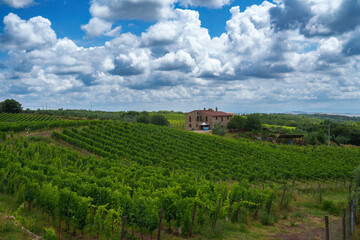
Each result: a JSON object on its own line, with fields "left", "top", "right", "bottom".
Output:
{"left": 53, "top": 121, "right": 360, "bottom": 181}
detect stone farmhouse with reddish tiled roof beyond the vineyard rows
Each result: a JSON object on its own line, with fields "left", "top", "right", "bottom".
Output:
{"left": 185, "top": 108, "right": 234, "bottom": 131}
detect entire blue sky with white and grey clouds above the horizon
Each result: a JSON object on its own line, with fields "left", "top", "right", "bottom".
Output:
{"left": 0, "top": 0, "right": 360, "bottom": 113}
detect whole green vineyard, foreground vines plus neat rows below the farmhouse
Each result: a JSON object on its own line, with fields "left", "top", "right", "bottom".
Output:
{"left": 0, "top": 115, "right": 360, "bottom": 239}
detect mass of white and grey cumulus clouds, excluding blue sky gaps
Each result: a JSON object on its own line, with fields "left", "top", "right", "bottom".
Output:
{"left": 0, "top": 0, "right": 360, "bottom": 110}
